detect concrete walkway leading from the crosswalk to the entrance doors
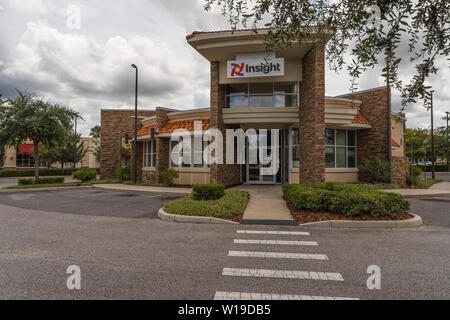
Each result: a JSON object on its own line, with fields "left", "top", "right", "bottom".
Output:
{"left": 232, "top": 185, "right": 296, "bottom": 225}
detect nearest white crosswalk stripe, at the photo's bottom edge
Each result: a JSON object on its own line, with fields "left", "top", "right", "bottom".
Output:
{"left": 214, "top": 291, "right": 359, "bottom": 300}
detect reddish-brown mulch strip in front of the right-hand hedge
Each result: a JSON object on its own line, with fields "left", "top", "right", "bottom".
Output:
{"left": 286, "top": 201, "right": 414, "bottom": 224}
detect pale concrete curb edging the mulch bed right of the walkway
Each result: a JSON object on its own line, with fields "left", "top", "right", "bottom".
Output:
{"left": 298, "top": 212, "right": 423, "bottom": 229}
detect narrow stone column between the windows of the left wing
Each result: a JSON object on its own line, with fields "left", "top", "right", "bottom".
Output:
{"left": 155, "top": 108, "right": 170, "bottom": 183}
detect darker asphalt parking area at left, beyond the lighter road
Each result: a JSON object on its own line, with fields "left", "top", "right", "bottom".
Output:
{"left": 0, "top": 189, "right": 179, "bottom": 218}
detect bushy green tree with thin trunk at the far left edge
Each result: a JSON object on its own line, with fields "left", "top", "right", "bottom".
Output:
{"left": 0, "top": 91, "right": 81, "bottom": 180}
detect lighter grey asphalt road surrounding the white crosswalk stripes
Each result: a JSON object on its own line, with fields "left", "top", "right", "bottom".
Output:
{"left": 0, "top": 190, "right": 450, "bottom": 300}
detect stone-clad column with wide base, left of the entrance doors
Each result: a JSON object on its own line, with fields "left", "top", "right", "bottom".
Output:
{"left": 210, "top": 61, "right": 241, "bottom": 186}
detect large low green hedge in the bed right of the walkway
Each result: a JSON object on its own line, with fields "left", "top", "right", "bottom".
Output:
{"left": 283, "top": 184, "right": 410, "bottom": 217}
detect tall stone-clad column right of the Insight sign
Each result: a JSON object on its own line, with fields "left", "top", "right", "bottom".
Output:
{"left": 299, "top": 45, "right": 325, "bottom": 183}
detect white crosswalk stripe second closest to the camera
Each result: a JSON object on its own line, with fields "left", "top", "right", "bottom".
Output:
{"left": 222, "top": 268, "right": 344, "bottom": 281}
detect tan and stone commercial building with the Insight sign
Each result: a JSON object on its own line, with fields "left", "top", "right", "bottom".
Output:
{"left": 100, "top": 30, "right": 408, "bottom": 186}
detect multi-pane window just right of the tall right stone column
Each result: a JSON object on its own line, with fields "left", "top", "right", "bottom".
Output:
{"left": 325, "top": 129, "right": 356, "bottom": 168}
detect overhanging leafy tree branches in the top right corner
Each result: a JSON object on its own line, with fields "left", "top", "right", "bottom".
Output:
{"left": 205, "top": 0, "right": 450, "bottom": 108}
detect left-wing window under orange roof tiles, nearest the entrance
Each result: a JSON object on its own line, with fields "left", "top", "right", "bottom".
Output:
{"left": 170, "top": 136, "right": 210, "bottom": 169}
